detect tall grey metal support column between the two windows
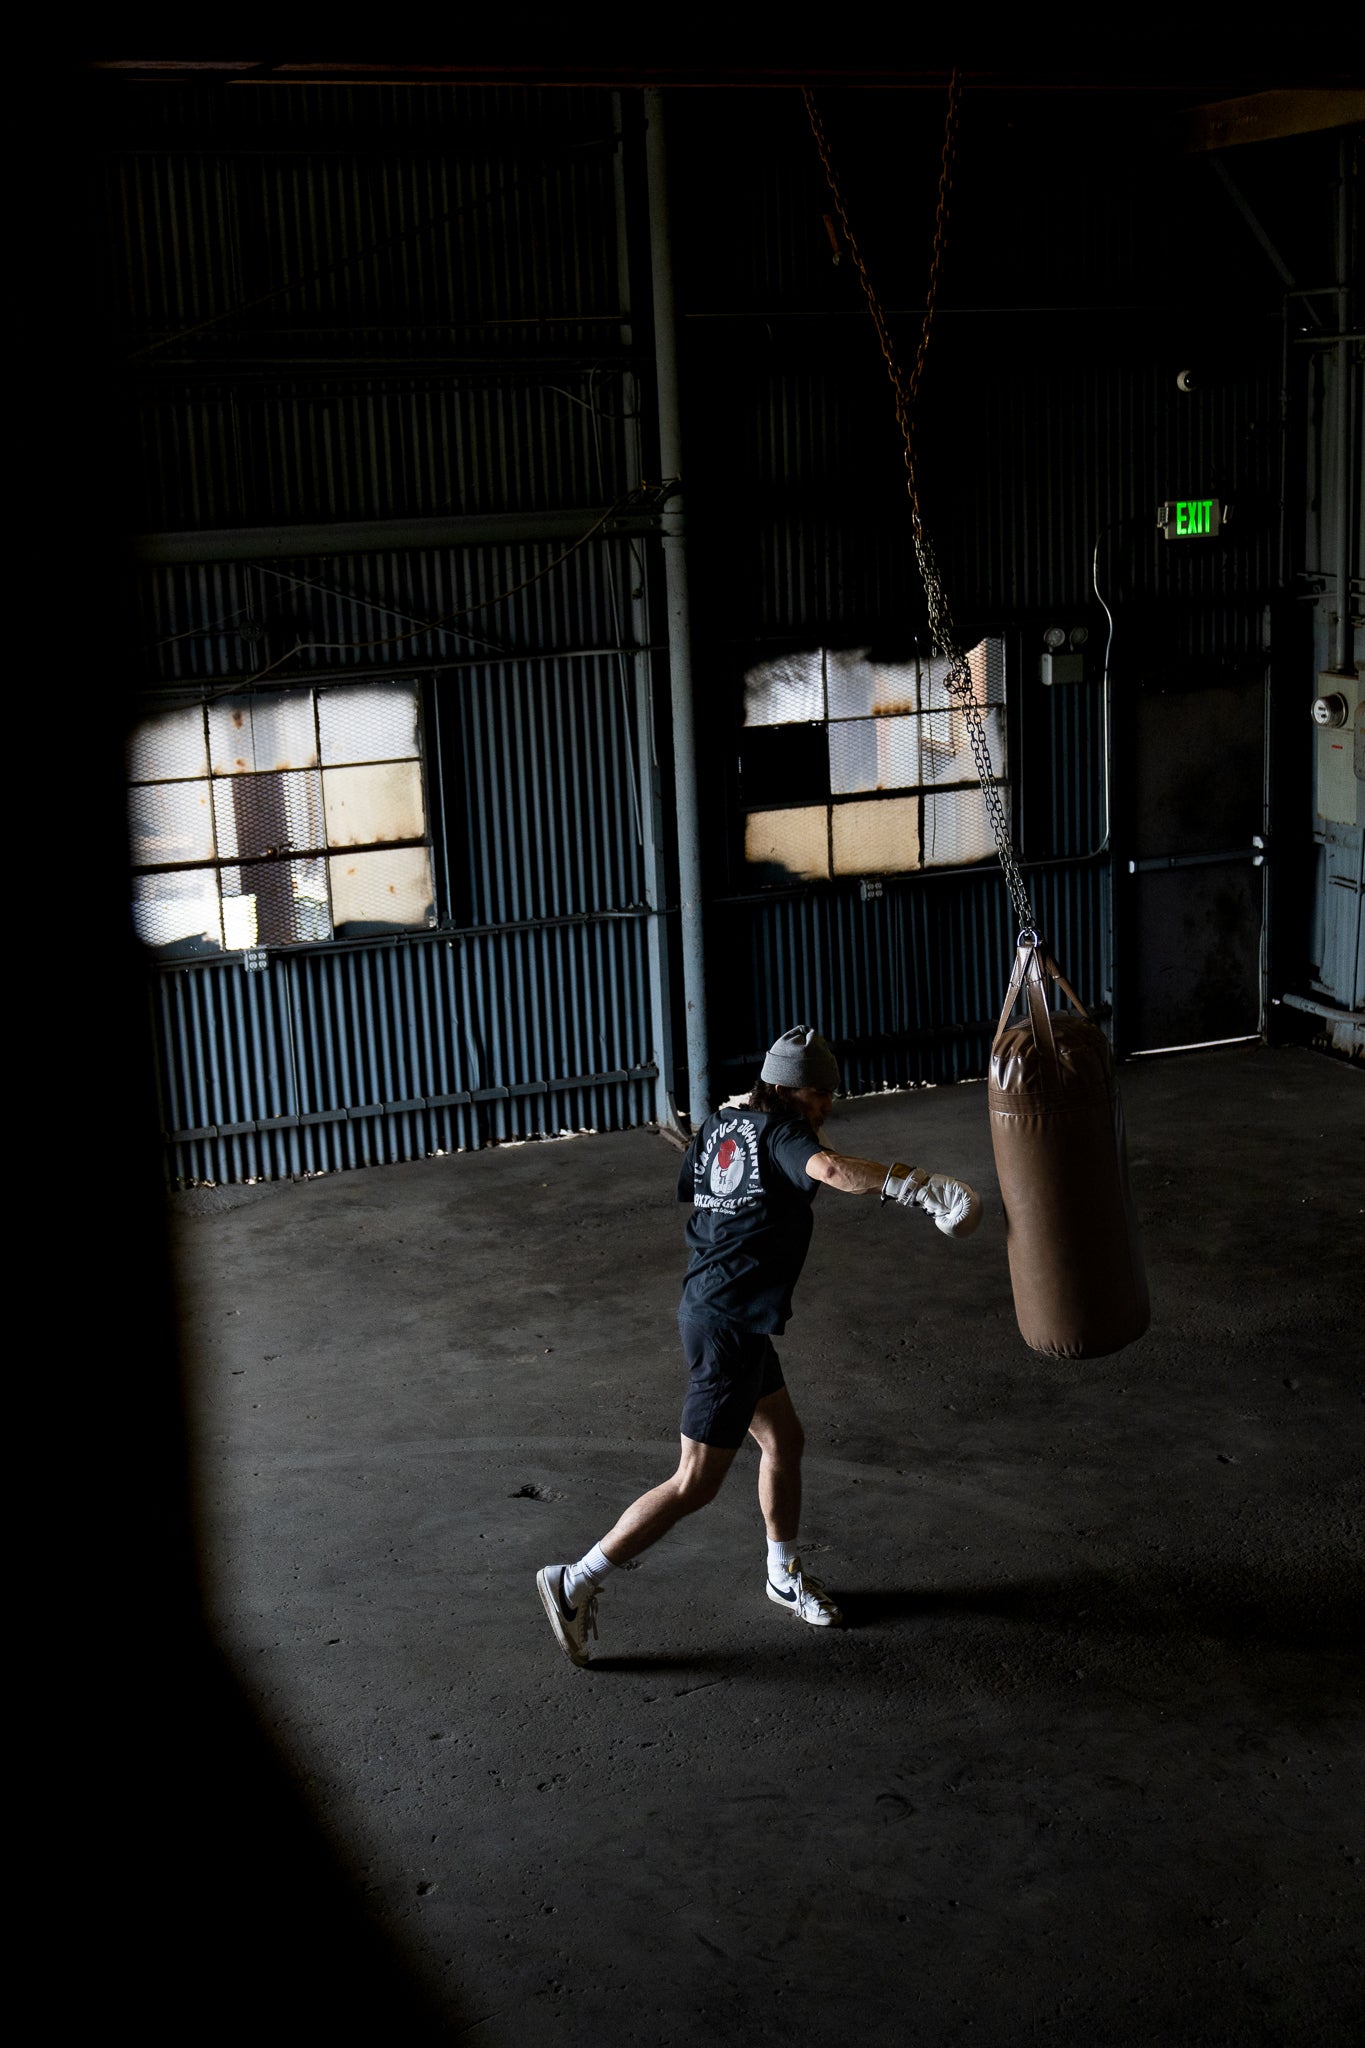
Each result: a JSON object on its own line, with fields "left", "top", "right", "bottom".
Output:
{"left": 645, "top": 88, "right": 710, "bottom": 1126}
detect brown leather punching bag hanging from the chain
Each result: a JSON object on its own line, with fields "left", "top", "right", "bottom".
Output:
{"left": 990, "top": 932, "right": 1152, "bottom": 1358}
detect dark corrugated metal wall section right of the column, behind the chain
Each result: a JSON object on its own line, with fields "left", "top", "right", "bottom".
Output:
{"left": 681, "top": 94, "right": 1279, "bottom": 1087}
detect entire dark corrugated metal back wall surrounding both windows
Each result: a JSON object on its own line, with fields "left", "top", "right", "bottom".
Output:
{"left": 106, "top": 84, "right": 1301, "bottom": 1180}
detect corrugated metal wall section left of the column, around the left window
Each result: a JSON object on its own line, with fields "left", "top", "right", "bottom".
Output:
{"left": 106, "top": 86, "right": 667, "bottom": 1180}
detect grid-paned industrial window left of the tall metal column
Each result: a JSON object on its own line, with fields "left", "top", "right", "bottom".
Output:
{"left": 129, "top": 682, "right": 434, "bottom": 954}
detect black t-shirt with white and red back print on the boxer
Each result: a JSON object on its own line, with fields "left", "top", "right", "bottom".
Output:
{"left": 677, "top": 1108, "right": 825, "bottom": 1335}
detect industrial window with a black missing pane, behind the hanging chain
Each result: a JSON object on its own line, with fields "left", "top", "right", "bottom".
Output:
{"left": 741, "top": 639, "right": 1009, "bottom": 881}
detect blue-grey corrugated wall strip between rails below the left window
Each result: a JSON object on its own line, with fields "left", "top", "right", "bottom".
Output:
{"left": 156, "top": 913, "right": 657, "bottom": 1182}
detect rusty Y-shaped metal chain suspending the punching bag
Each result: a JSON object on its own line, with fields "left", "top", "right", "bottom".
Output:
{"left": 802, "top": 72, "right": 1033, "bottom": 932}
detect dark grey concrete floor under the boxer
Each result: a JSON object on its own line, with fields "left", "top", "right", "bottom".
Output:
{"left": 172, "top": 1047, "right": 1365, "bottom": 2048}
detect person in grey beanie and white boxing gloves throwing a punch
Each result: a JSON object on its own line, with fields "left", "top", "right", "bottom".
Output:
{"left": 536, "top": 1024, "right": 980, "bottom": 1665}
